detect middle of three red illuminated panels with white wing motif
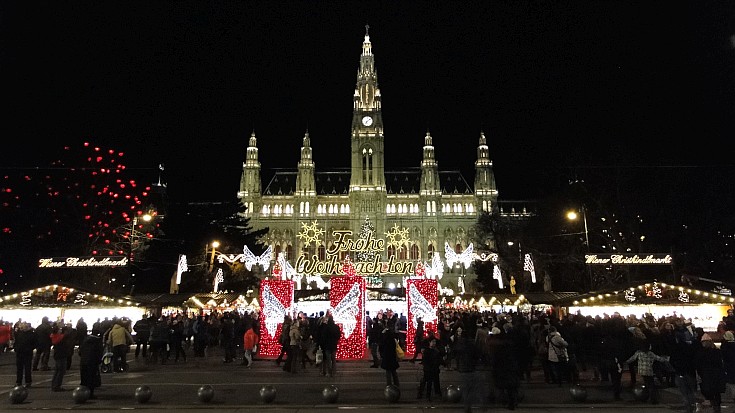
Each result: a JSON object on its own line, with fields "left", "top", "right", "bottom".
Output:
{"left": 329, "top": 272, "right": 366, "bottom": 360}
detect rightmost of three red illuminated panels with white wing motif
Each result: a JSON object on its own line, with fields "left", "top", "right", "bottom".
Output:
{"left": 406, "top": 278, "right": 439, "bottom": 354}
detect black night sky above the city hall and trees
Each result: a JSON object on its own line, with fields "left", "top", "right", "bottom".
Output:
{"left": 0, "top": 0, "right": 735, "bottom": 206}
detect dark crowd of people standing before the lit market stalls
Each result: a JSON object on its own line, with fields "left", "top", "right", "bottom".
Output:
{"left": 0, "top": 309, "right": 735, "bottom": 413}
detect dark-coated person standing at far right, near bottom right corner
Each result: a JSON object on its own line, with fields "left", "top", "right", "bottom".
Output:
{"left": 694, "top": 334, "right": 725, "bottom": 413}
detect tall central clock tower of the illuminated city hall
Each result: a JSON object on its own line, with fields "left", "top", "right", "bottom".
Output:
{"left": 350, "top": 26, "right": 386, "bottom": 231}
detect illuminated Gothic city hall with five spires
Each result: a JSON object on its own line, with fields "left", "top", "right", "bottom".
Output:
{"left": 238, "top": 28, "right": 525, "bottom": 293}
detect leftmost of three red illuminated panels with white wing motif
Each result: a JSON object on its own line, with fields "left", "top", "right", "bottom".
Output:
{"left": 258, "top": 280, "right": 294, "bottom": 356}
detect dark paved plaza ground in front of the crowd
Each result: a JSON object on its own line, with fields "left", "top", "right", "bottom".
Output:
{"left": 0, "top": 351, "right": 735, "bottom": 413}
